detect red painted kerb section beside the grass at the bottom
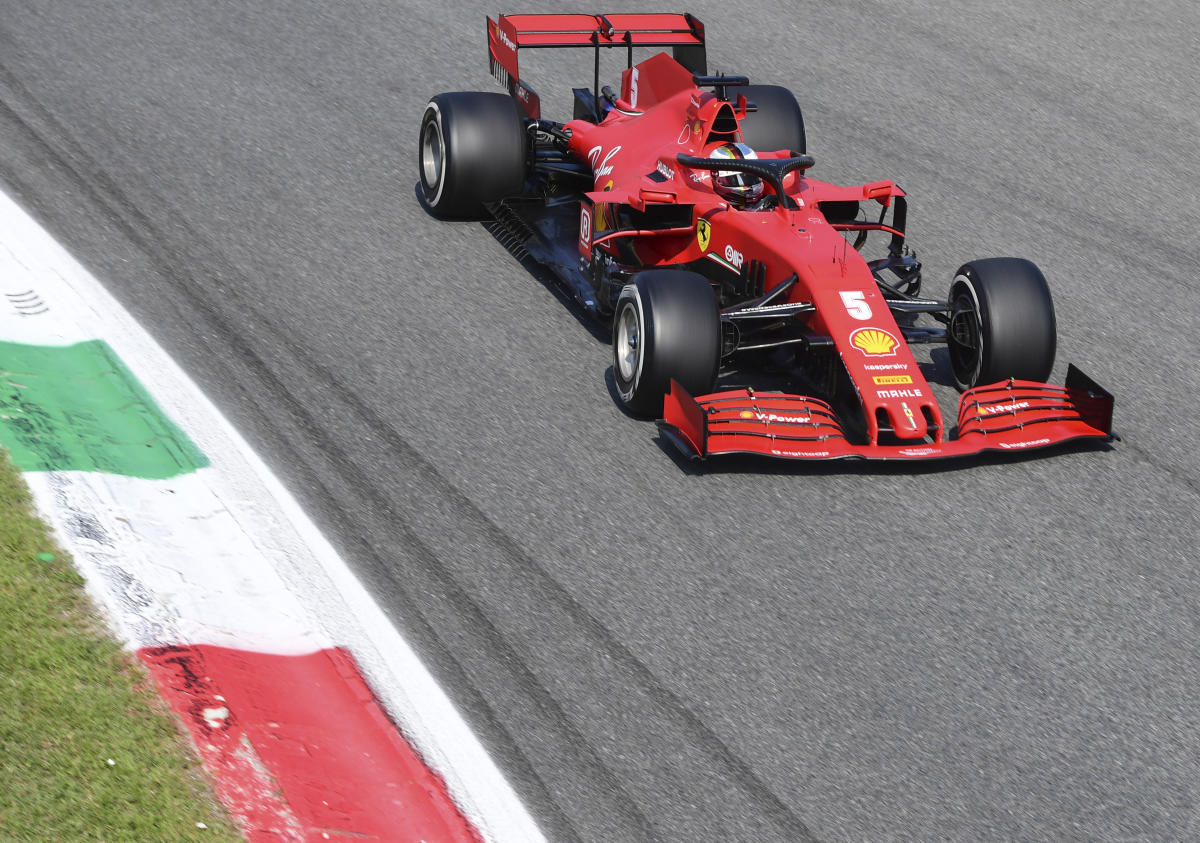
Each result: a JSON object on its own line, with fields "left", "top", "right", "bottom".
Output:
{"left": 138, "top": 645, "right": 480, "bottom": 843}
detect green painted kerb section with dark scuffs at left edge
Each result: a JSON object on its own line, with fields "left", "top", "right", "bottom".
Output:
{"left": 0, "top": 340, "right": 209, "bottom": 479}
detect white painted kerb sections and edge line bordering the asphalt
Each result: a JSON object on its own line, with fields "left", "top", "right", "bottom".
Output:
{"left": 0, "top": 192, "right": 545, "bottom": 843}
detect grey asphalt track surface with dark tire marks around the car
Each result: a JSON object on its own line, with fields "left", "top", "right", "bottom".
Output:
{"left": 0, "top": 0, "right": 1200, "bottom": 841}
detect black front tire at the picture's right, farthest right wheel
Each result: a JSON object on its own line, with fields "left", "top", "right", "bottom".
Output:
{"left": 948, "top": 258, "right": 1057, "bottom": 390}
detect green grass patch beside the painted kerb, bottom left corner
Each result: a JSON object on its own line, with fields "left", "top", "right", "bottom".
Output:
{"left": 0, "top": 456, "right": 241, "bottom": 841}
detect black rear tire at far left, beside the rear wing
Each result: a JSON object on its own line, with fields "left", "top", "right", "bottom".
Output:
{"left": 416, "top": 91, "right": 528, "bottom": 217}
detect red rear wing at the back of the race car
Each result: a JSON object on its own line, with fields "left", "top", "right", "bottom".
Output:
{"left": 487, "top": 13, "right": 708, "bottom": 120}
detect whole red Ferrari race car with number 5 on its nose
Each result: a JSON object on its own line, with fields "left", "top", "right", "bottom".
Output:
{"left": 419, "top": 14, "right": 1114, "bottom": 459}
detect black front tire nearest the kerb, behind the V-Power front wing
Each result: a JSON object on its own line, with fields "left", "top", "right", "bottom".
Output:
{"left": 612, "top": 269, "right": 721, "bottom": 417}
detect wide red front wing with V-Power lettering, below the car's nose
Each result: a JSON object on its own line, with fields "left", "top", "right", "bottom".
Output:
{"left": 659, "top": 365, "right": 1116, "bottom": 460}
